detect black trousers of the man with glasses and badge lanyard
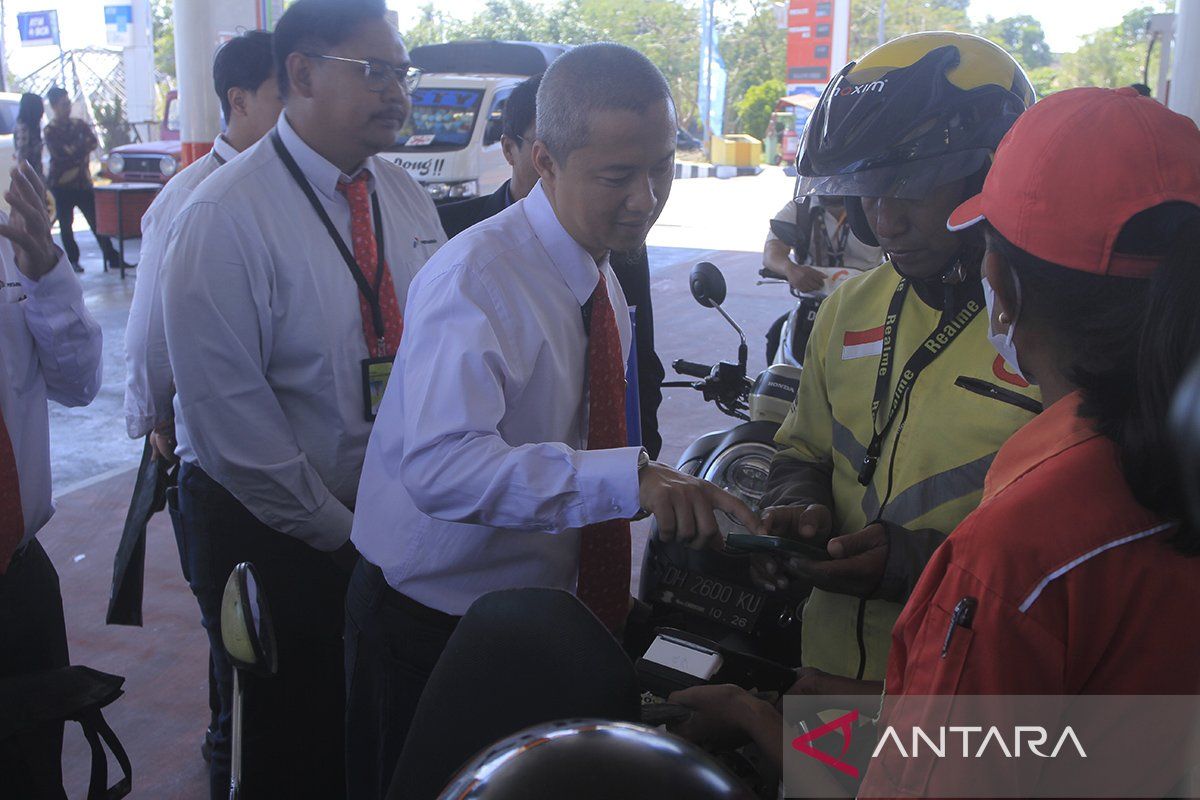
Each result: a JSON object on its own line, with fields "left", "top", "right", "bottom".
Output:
{"left": 179, "top": 463, "right": 349, "bottom": 800}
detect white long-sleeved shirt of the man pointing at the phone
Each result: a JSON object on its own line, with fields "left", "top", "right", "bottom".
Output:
{"left": 352, "top": 184, "right": 640, "bottom": 614}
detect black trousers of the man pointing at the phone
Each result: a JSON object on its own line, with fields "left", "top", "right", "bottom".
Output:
{"left": 346, "top": 559, "right": 467, "bottom": 800}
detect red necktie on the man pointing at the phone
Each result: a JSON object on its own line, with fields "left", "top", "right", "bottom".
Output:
{"left": 576, "top": 272, "right": 630, "bottom": 631}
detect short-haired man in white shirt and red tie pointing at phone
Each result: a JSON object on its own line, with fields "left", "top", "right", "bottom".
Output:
{"left": 346, "top": 44, "right": 761, "bottom": 800}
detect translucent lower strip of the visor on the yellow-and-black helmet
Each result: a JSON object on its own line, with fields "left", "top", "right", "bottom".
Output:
{"left": 796, "top": 149, "right": 990, "bottom": 200}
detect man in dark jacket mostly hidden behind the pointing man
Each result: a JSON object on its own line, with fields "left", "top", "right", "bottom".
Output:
{"left": 438, "top": 74, "right": 666, "bottom": 458}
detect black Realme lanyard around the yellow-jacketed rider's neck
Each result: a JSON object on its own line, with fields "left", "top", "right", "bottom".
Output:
{"left": 858, "top": 278, "right": 984, "bottom": 486}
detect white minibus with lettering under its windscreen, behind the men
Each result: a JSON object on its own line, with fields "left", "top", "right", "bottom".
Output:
{"left": 379, "top": 40, "right": 566, "bottom": 201}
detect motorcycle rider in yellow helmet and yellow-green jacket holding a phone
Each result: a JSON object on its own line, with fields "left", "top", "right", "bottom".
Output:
{"left": 755, "top": 32, "right": 1039, "bottom": 693}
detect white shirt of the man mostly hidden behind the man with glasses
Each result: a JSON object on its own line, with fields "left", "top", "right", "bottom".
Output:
{"left": 125, "top": 136, "right": 238, "bottom": 439}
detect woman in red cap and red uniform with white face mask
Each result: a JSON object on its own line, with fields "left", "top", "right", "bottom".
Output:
{"left": 671, "top": 81, "right": 1200, "bottom": 798}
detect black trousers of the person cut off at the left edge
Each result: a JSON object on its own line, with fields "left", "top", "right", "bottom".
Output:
{"left": 0, "top": 539, "right": 70, "bottom": 800}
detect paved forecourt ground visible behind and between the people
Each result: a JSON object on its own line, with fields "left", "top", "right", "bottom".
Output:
{"left": 38, "top": 169, "right": 791, "bottom": 800}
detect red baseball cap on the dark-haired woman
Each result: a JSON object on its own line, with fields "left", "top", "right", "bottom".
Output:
{"left": 947, "top": 88, "right": 1200, "bottom": 277}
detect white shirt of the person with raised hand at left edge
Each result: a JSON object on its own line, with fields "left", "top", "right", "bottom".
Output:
{"left": 0, "top": 247, "right": 101, "bottom": 546}
